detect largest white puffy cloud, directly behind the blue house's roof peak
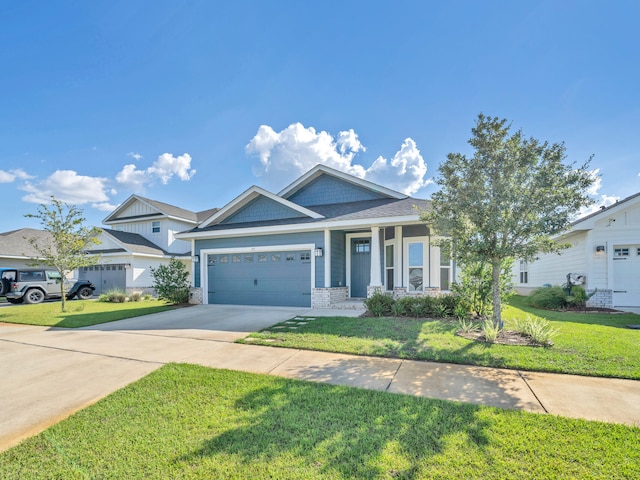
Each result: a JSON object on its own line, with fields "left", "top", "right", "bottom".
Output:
{"left": 245, "top": 123, "right": 430, "bottom": 195}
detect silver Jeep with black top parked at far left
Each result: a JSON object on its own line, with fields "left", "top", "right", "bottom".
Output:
{"left": 0, "top": 268, "right": 96, "bottom": 304}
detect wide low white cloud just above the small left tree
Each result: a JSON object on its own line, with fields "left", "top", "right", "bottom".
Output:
{"left": 20, "top": 170, "right": 109, "bottom": 205}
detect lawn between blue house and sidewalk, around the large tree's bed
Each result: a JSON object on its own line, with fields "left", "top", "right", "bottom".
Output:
{"left": 241, "top": 297, "right": 640, "bottom": 379}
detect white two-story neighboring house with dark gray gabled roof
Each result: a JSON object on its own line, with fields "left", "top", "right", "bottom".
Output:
{"left": 79, "top": 195, "right": 216, "bottom": 293}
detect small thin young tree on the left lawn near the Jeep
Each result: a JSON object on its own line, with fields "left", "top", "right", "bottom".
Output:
{"left": 25, "top": 196, "right": 100, "bottom": 312}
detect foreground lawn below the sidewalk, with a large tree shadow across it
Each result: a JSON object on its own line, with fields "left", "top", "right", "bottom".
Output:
{"left": 0, "top": 364, "right": 640, "bottom": 479}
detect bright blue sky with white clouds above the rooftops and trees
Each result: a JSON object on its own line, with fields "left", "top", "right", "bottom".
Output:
{"left": 0, "top": 0, "right": 640, "bottom": 232}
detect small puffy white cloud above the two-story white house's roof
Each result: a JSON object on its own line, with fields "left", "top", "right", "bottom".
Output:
{"left": 116, "top": 153, "right": 196, "bottom": 192}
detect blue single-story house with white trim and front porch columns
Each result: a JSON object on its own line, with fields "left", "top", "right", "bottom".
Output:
{"left": 176, "top": 165, "right": 452, "bottom": 308}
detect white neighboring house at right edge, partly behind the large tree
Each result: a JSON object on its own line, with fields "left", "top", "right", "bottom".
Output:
{"left": 514, "top": 193, "right": 640, "bottom": 307}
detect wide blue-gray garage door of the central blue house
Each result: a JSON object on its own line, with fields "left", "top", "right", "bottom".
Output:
{"left": 207, "top": 250, "right": 311, "bottom": 307}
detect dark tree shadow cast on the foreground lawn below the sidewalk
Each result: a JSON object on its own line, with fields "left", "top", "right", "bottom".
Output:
{"left": 177, "top": 379, "right": 489, "bottom": 478}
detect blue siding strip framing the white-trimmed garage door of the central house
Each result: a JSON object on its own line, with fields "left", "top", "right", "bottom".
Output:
{"left": 194, "top": 231, "right": 325, "bottom": 287}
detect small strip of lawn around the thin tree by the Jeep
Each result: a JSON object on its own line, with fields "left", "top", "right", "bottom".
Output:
{"left": 0, "top": 300, "right": 172, "bottom": 328}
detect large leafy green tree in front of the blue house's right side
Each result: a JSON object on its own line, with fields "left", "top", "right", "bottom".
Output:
{"left": 422, "top": 114, "right": 597, "bottom": 325}
